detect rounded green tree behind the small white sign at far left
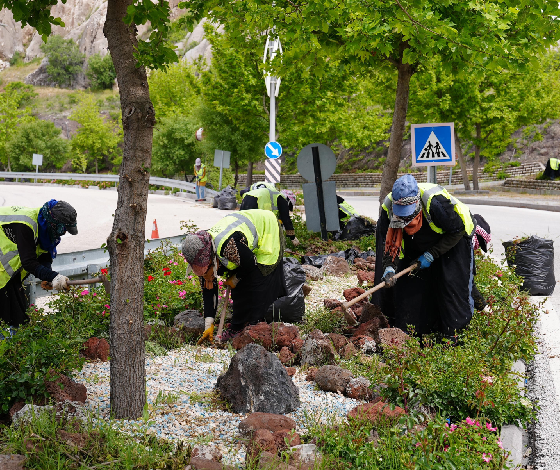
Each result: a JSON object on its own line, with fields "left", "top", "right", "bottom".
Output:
{"left": 6, "top": 119, "right": 70, "bottom": 171}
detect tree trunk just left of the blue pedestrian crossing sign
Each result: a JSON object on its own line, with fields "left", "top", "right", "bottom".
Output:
{"left": 379, "top": 61, "right": 414, "bottom": 203}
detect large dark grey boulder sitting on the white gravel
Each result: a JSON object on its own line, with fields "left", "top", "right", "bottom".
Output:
{"left": 216, "top": 343, "right": 300, "bottom": 414}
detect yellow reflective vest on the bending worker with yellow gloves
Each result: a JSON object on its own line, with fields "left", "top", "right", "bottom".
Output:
{"left": 208, "top": 209, "right": 281, "bottom": 270}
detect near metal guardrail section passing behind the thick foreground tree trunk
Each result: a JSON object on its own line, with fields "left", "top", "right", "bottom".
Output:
{"left": 24, "top": 235, "right": 185, "bottom": 304}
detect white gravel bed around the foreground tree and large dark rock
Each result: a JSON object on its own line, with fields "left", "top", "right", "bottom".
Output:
{"left": 75, "top": 346, "right": 362, "bottom": 467}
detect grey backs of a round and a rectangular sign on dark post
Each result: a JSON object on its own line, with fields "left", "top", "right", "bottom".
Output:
{"left": 297, "top": 144, "right": 340, "bottom": 240}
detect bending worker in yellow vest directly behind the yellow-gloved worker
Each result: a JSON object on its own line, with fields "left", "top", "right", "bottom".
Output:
{"left": 240, "top": 186, "right": 299, "bottom": 246}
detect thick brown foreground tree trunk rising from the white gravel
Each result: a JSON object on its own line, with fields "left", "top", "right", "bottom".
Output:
{"left": 103, "top": 0, "right": 155, "bottom": 419}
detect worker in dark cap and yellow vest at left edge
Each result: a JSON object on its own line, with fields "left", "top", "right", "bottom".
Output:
{"left": 0, "top": 199, "right": 78, "bottom": 328}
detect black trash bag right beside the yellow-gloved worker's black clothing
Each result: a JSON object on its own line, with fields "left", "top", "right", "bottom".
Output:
{"left": 266, "top": 258, "right": 305, "bottom": 323}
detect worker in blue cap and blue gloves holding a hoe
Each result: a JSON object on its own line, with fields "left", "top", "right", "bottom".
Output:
{"left": 372, "top": 175, "right": 475, "bottom": 337}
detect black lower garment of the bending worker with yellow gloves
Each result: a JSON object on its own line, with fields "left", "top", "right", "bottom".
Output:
{"left": 231, "top": 260, "right": 286, "bottom": 330}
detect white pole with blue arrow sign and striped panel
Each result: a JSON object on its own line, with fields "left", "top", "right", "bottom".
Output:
{"left": 263, "top": 36, "right": 282, "bottom": 183}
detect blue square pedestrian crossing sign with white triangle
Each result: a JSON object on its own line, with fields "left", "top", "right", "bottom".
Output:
{"left": 410, "top": 122, "right": 455, "bottom": 166}
